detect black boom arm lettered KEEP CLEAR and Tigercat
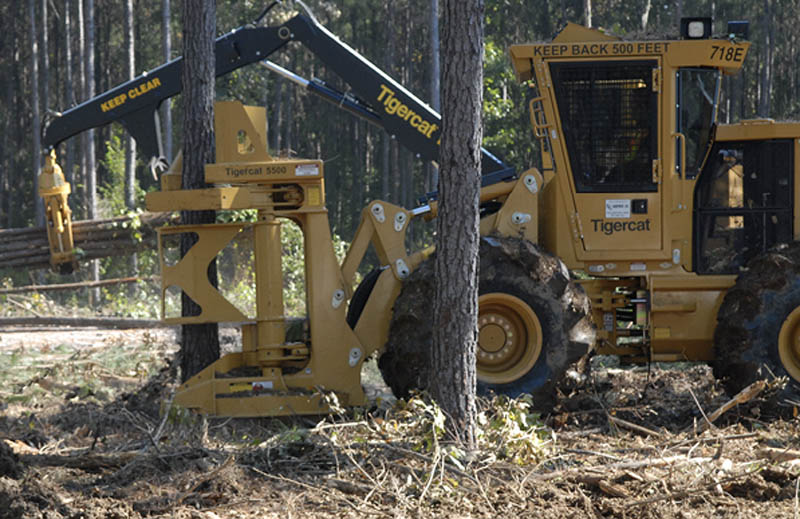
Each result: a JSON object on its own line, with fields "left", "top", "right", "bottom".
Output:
{"left": 43, "top": 10, "right": 513, "bottom": 175}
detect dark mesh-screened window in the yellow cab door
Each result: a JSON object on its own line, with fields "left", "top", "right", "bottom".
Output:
{"left": 550, "top": 61, "right": 657, "bottom": 192}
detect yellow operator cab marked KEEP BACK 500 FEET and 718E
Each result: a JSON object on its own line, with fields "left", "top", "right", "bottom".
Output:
{"left": 510, "top": 19, "right": 749, "bottom": 276}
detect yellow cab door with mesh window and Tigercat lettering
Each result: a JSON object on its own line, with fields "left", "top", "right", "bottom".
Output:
{"left": 550, "top": 58, "right": 665, "bottom": 260}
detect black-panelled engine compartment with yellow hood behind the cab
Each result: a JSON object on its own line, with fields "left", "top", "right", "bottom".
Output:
{"left": 694, "top": 119, "right": 800, "bottom": 274}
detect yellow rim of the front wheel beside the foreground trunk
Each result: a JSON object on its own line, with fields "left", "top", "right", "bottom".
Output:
{"left": 475, "top": 293, "right": 542, "bottom": 384}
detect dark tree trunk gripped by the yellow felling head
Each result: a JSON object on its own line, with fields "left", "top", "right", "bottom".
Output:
{"left": 180, "top": 0, "right": 219, "bottom": 380}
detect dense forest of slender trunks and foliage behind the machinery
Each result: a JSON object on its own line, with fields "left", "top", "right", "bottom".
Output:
{"left": 0, "top": 0, "right": 800, "bottom": 310}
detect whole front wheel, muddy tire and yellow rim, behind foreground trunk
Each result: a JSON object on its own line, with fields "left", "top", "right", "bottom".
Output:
{"left": 378, "top": 237, "right": 595, "bottom": 412}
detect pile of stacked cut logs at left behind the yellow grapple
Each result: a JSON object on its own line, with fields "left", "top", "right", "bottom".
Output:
{"left": 0, "top": 213, "right": 178, "bottom": 269}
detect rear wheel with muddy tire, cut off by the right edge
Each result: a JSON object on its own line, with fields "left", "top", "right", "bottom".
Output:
{"left": 713, "top": 242, "right": 800, "bottom": 401}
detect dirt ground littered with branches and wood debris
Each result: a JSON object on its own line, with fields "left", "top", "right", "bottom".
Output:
{"left": 0, "top": 329, "right": 800, "bottom": 519}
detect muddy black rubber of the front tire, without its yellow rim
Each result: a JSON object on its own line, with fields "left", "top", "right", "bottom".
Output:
{"left": 378, "top": 237, "right": 595, "bottom": 411}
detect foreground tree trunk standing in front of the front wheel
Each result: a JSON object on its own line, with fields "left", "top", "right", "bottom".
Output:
{"left": 430, "top": 0, "right": 483, "bottom": 449}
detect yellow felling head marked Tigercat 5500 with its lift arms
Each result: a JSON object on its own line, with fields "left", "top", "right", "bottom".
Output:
{"left": 141, "top": 103, "right": 543, "bottom": 416}
